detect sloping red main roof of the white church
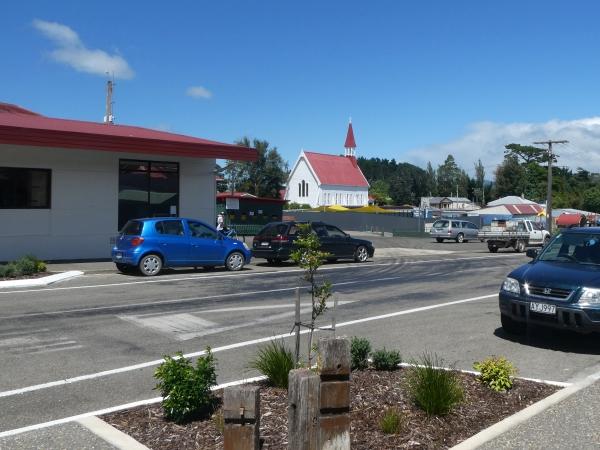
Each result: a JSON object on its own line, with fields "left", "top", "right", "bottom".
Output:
{"left": 304, "top": 151, "right": 369, "bottom": 187}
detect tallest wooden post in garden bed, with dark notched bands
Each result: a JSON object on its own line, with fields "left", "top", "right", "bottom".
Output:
{"left": 318, "top": 338, "right": 350, "bottom": 450}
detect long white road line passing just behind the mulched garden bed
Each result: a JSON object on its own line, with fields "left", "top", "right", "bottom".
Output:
{"left": 0, "top": 293, "right": 498, "bottom": 400}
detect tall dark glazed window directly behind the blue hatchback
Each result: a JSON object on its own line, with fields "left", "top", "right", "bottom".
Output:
{"left": 119, "top": 160, "right": 179, "bottom": 228}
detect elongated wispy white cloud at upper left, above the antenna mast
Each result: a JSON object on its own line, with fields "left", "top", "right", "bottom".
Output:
{"left": 33, "top": 19, "right": 134, "bottom": 79}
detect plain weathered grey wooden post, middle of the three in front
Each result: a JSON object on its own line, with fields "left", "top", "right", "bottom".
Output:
{"left": 288, "top": 369, "right": 319, "bottom": 450}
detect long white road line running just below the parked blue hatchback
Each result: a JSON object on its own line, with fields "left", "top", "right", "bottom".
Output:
{"left": 0, "top": 253, "right": 519, "bottom": 296}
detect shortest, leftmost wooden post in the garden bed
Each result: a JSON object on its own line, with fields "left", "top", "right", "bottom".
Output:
{"left": 223, "top": 386, "right": 260, "bottom": 450}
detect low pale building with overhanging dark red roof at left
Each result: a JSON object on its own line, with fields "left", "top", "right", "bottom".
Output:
{"left": 0, "top": 103, "right": 257, "bottom": 261}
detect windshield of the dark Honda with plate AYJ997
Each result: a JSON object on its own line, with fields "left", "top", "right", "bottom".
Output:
{"left": 539, "top": 233, "right": 600, "bottom": 265}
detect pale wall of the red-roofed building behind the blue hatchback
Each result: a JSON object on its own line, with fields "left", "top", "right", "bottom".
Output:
{"left": 0, "top": 145, "right": 215, "bottom": 261}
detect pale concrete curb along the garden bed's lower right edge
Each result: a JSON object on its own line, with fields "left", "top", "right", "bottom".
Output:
{"left": 451, "top": 372, "right": 600, "bottom": 450}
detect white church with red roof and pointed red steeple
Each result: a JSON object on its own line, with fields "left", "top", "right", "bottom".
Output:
{"left": 285, "top": 122, "right": 369, "bottom": 208}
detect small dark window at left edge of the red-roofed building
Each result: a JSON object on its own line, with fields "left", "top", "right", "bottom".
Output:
{"left": 0, "top": 167, "right": 51, "bottom": 209}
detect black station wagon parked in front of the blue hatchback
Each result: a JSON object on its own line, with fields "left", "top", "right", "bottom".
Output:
{"left": 252, "top": 222, "right": 375, "bottom": 264}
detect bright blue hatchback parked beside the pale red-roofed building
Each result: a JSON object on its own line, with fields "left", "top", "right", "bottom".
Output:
{"left": 112, "top": 217, "right": 252, "bottom": 276}
